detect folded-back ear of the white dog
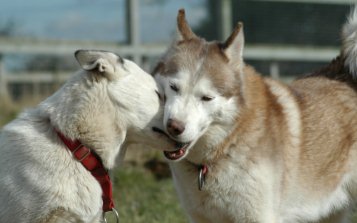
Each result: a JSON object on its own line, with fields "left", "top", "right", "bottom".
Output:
{"left": 74, "top": 50, "right": 123, "bottom": 79}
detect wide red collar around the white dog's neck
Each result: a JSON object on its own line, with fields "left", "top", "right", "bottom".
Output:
{"left": 56, "top": 130, "right": 114, "bottom": 212}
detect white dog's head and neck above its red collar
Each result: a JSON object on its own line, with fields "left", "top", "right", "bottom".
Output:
{"left": 46, "top": 50, "right": 175, "bottom": 168}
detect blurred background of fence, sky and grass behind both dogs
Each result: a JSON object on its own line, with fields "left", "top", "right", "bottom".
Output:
{"left": 0, "top": 0, "right": 357, "bottom": 223}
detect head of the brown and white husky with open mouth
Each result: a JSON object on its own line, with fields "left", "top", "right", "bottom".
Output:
{"left": 153, "top": 10, "right": 244, "bottom": 160}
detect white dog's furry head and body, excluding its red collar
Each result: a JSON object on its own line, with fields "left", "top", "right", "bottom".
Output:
{"left": 0, "top": 50, "right": 173, "bottom": 223}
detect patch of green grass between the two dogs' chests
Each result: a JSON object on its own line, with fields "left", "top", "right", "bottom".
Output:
{"left": 110, "top": 165, "right": 187, "bottom": 223}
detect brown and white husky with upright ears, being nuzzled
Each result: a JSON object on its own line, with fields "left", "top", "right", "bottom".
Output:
{"left": 154, "top": 10, "right": 357, "bottom": 223}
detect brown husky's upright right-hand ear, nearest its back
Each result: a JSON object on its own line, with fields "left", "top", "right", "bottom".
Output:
{"left": 223, "top": 22, "right": 244, "bottom": 65}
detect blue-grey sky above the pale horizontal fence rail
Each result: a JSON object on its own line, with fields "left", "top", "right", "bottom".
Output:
{"left": 0, "top": 0, "right": 207, "bottom": 43}
